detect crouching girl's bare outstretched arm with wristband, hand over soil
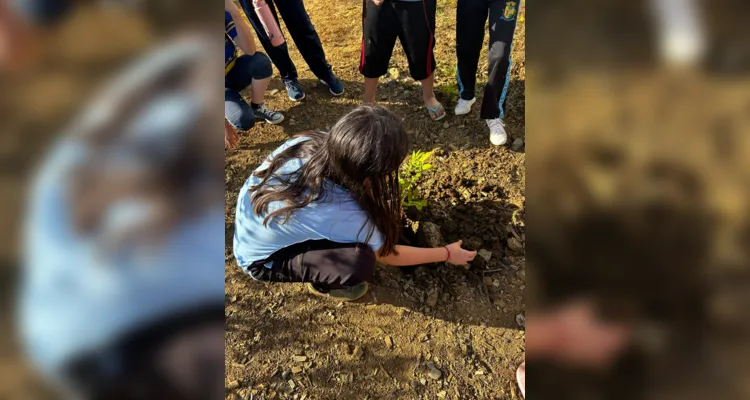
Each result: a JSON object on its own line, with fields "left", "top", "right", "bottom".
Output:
{"left": 378, "top": 240, "right": 477, "bottom": 267}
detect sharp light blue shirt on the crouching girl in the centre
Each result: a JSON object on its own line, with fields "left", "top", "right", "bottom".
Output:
{"left": 234, "top": 138, "right": 383, "bottom": 270}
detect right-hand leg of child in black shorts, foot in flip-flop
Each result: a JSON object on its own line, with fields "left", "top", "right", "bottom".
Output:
{"left": 394, "top": 0, "right": 445, "bottom": 121}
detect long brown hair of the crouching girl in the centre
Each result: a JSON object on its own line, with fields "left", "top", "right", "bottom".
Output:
{"left": 250, "top": 106, "right": 409, "bottom": 255}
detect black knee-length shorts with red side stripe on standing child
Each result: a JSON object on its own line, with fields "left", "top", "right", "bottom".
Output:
{"left": 359, "top": 0, "right": 436, "bottom": 81}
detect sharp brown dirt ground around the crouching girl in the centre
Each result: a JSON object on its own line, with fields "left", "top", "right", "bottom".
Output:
{"left": 225, "top": 0, "right": 526, "bottom": 399}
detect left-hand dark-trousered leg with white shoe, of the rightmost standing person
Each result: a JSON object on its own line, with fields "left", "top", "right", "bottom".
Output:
{"left": 456, "top": 0, "right": 489, "bottom": 115}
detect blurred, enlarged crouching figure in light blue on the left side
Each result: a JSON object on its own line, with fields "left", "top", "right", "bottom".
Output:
{"left": 18, "top": 36, "right": 224, "bottom": 400}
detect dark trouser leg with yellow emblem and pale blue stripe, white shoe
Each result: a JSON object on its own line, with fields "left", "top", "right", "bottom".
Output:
{"left": 481, "top": 0, "right": 519, "bottom": 146}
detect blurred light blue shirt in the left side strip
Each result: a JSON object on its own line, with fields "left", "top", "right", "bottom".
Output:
{"left": 18, "top": 139, "right": 224, "bottom": 381}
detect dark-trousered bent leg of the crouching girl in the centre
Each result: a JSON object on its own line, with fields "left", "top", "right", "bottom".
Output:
{"left": 250, "top": 240, "right": 375, "bottom": 290}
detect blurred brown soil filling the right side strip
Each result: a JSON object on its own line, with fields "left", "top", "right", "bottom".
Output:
{"left": 526, "top": 0, "right": 750, "bottom": 400}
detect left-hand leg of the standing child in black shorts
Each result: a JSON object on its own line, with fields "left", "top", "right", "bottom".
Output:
{"left": 359, "top": 0, "right": 399, "bottom": 104}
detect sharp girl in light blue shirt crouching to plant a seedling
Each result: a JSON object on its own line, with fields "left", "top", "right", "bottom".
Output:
{"left": 234, "top": 106, "right": 476, "bottom": 301}
